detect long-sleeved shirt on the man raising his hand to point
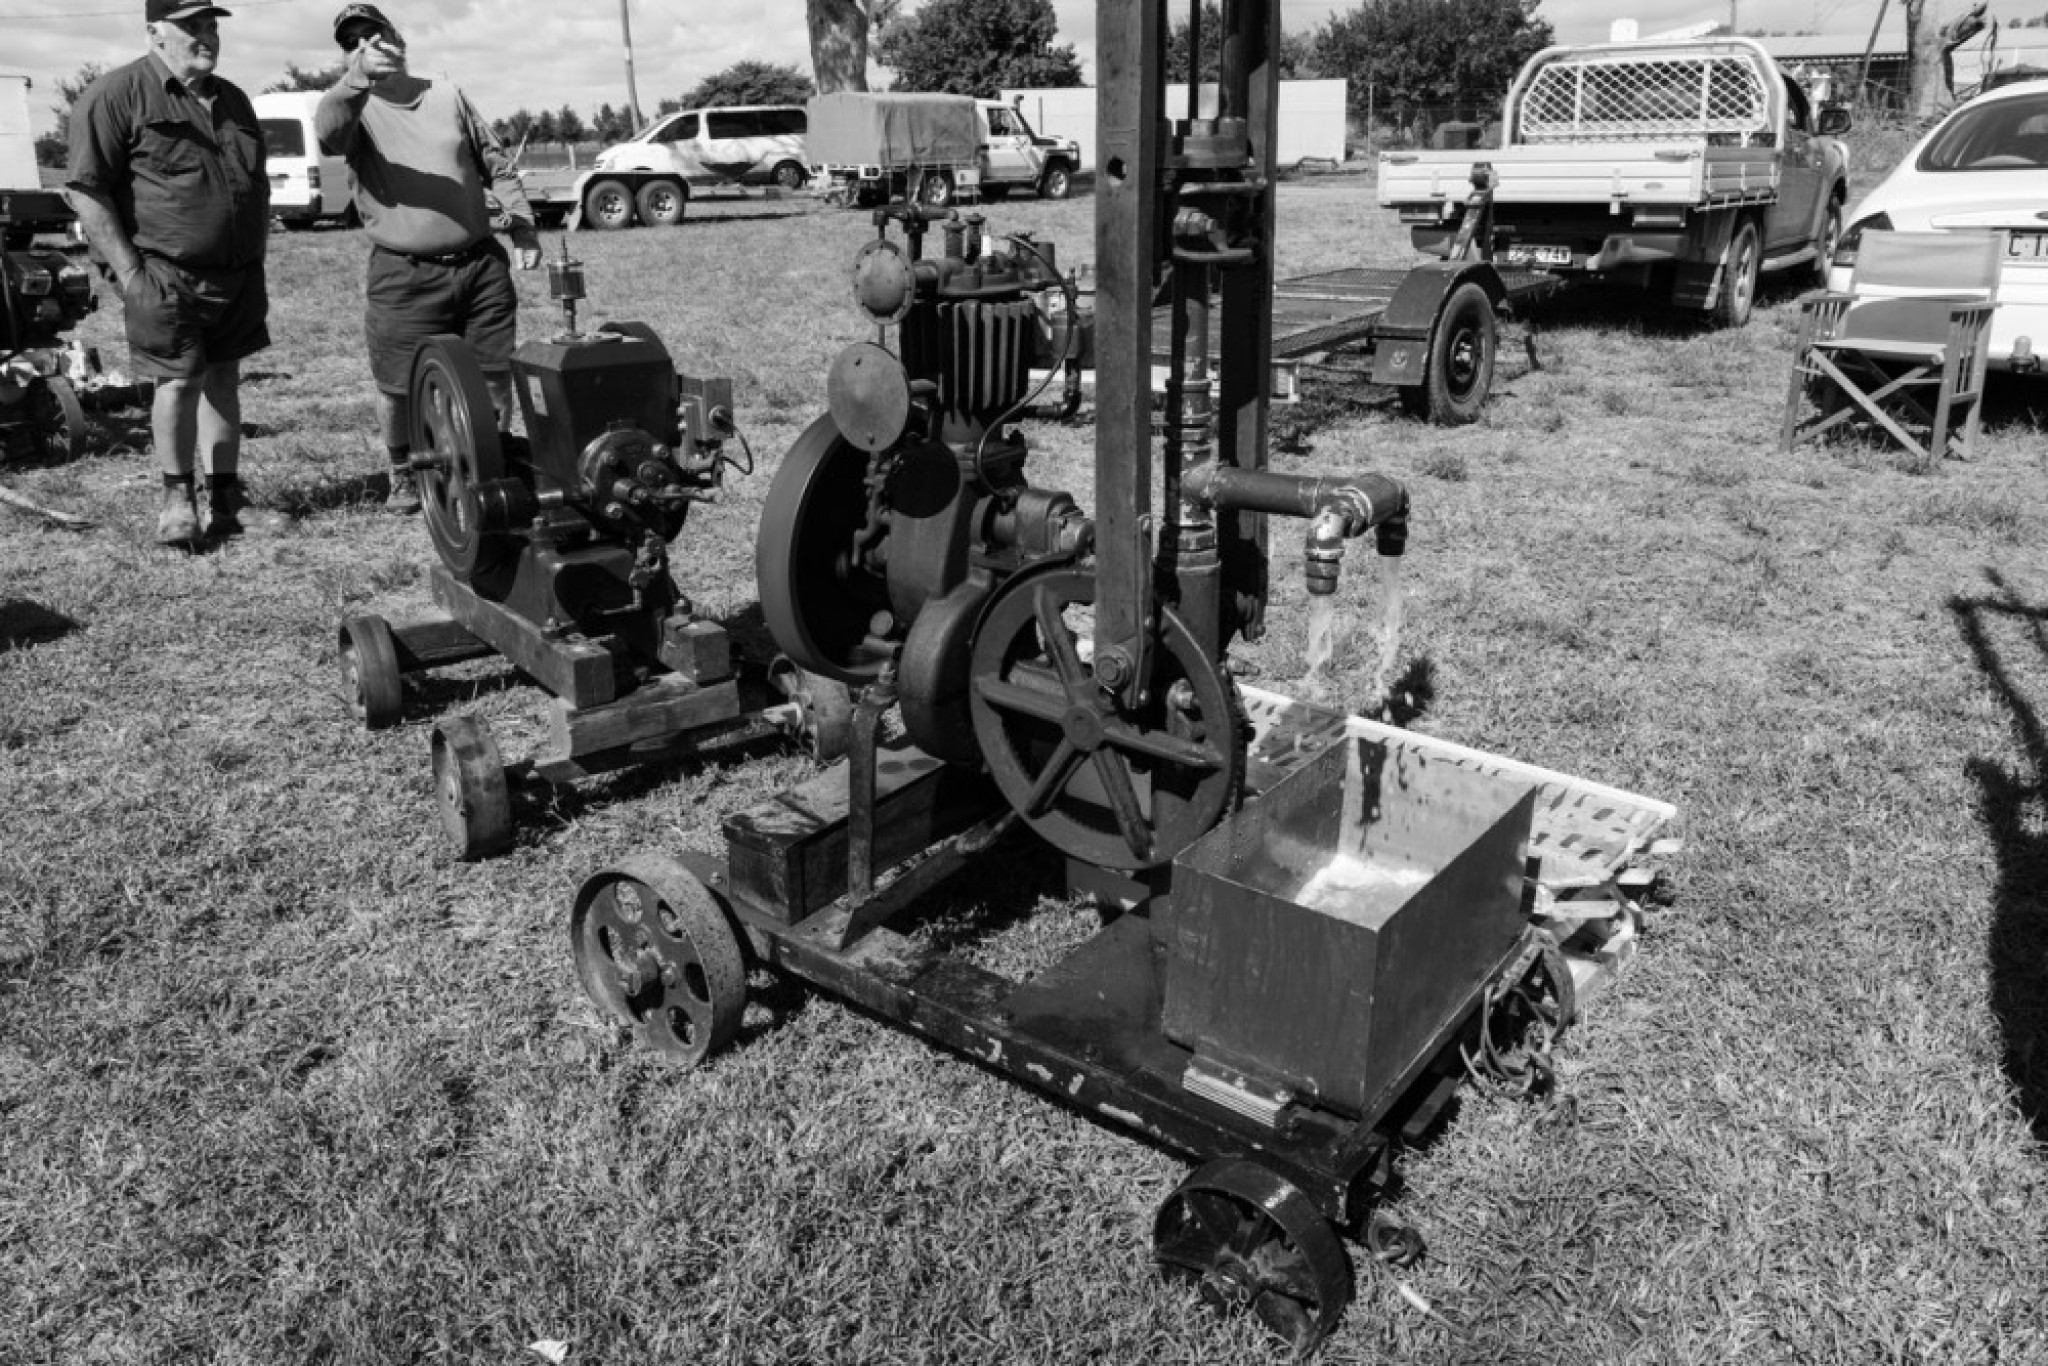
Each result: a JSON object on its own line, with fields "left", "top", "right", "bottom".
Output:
{"left": 313, "top": 74, "right": 532, "bottom": 256}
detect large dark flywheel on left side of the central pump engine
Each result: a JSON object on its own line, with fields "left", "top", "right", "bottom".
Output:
{"left": 754, "top": 414, "right": 889, "bottom": 686}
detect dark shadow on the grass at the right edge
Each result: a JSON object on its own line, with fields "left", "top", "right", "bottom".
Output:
{"left": 1950, "top": 571, "right": 2048, "bottom": 1143}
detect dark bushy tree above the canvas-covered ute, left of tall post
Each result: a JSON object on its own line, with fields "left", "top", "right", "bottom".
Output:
{"left": 874, "top": 0, "right": 1081, "bottom": 96}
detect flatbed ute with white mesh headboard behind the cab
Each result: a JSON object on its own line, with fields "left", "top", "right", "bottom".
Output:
{"left": 1380, "top": 39, "right": 1849, "bottom": 328}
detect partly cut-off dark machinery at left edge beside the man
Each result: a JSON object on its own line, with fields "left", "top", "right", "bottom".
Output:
{"left": 0, "top": 248, "right": 96, "bottom": 461}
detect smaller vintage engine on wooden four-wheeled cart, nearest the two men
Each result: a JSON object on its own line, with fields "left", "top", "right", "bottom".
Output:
{"left": 340, "top": 254, "right": 846, "bottom": 858}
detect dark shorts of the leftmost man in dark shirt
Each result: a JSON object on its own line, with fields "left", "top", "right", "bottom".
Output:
{"left": 121, "top": 256, "right": 270, "bottom": 379}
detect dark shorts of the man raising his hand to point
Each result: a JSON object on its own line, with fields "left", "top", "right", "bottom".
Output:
{"left": 362, "top": 238, "right": 518, "bottom": 395}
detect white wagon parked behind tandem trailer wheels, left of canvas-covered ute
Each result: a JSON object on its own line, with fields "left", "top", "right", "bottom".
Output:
{"left": 573, "top": 104, "right": 809, "bottom": 227}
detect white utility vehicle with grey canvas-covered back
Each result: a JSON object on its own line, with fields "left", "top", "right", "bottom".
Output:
{"left": 807, "top": 92, "right": 1081, "bottom": 207}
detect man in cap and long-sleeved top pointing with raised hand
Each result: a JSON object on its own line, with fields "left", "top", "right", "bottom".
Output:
{"left": 313, "top": 4, "right": 541, "bottom": 512}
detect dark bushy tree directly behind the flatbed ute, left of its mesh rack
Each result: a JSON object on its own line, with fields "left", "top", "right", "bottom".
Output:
{"left": 1315, "top": 0, "right": 1552, "bottom": 127}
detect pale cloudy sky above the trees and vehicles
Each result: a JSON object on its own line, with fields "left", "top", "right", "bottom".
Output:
{"left": 0, "top": 0, "right": 1916, "bottom": 129}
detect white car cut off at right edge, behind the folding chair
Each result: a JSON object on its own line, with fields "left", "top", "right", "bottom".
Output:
{"left": 1827, "top": 80, "right": 2048, "bottom": 375}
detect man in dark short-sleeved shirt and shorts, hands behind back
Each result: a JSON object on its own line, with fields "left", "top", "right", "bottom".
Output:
{"left": 66, "top": 0, "right": 270, "bottom": 547}
